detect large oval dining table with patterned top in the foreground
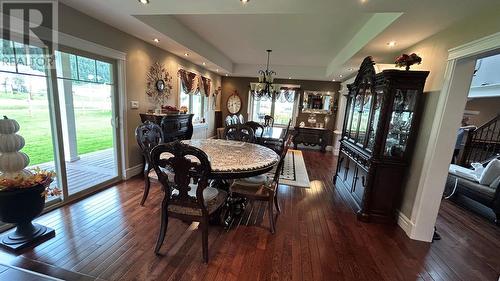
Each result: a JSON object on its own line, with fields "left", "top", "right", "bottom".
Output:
{"left": 182, "top": 139, "right": 280, "bottom": 228}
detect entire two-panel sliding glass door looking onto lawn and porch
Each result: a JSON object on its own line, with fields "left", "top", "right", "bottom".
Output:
{"left": 0, "top": 36, "right": 120, "bottom": 203}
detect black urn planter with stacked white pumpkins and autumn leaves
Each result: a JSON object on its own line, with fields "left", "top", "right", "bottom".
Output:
{"left": 0, "top": 116, "right": 60, "bottom": 251}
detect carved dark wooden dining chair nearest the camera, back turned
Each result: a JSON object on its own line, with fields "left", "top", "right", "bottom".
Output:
{"left": 151, "top": 141, "right": 227, "bottom": 263}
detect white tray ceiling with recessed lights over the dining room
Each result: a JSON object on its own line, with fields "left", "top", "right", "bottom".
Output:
{"left": 61, "top": 0, "right": 500, "bottom": 80}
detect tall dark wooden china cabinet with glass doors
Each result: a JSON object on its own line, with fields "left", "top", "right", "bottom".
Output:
{"left": 333, "top": 57, "right": 429, "bottom": 223}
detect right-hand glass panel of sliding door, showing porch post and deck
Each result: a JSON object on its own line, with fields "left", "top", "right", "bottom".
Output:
{"left": 56, "top": 51, "right": 118, "bottom": 195}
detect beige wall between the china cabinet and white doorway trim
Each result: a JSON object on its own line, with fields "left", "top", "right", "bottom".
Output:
{"left": 395, "top": 7, "right": 500, "bottom": 215}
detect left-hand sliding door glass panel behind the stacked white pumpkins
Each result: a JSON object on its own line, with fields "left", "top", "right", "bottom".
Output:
{"left": 0, "top": 39, "right": 61, "bottom": 202}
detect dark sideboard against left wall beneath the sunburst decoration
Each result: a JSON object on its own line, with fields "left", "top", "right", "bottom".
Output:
{"left": 140, "top": 113, "right": 193, "bottom": 142}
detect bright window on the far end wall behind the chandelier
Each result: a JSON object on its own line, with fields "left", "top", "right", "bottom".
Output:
{"left": 249, "top": 87, "right": 298, "bottom": 126}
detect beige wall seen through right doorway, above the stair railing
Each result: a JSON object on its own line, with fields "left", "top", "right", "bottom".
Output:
{"left": 465, "top": 97, "right": 500, "bottom": 127}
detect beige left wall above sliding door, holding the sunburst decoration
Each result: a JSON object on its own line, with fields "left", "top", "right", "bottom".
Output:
{"left": 59, "top": 4, "right": 221, "bottom": 168}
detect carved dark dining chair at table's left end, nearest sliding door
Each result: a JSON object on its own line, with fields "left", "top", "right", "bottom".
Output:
{"left": 135, "top": 120, "right": 163, "bottom": 206}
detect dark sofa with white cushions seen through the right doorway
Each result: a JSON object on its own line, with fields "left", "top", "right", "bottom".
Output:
{"left": 444, "top": 157, "right": 500, "bottom": 225}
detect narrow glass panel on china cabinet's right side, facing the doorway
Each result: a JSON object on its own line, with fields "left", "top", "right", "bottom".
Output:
{"left": 384, "top": 89, "right": 418, "bottom": 158}
